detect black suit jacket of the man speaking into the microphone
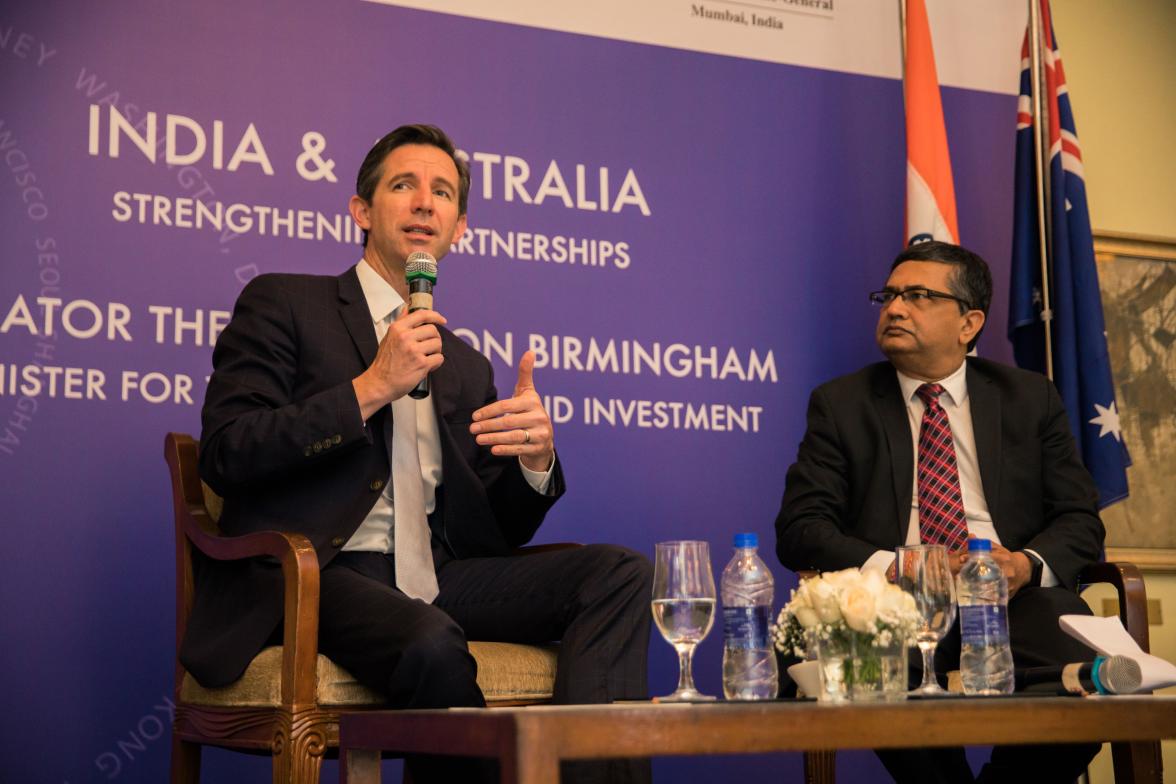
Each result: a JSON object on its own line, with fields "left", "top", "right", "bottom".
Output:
{"left": 180, "top": 268, "right": 563, "bottom": 685}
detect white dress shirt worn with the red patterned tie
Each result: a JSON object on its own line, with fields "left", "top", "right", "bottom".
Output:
{"left": 862, "top": 361, "right": 1058, "bottom": 585}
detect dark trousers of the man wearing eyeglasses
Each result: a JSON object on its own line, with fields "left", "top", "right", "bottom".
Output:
{"left": 877, "top": 588, "right": 1100, "bottom": 784}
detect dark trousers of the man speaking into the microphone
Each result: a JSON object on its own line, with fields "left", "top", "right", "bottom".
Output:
{"left": 319, "top": 544, "right": 653, "bottom": 784}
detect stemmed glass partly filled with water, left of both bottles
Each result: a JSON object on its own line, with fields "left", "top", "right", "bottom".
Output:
{"left": 653, "top": 542, "right": 715, "bottom": 702}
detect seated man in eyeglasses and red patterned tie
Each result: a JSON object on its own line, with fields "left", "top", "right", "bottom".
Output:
{"left": 776, "top": 242, "right": 1104, "bottom": 783}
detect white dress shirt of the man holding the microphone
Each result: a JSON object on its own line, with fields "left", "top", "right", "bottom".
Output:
{"left": 343, "top": 259, "right": 555, "bottom": 552}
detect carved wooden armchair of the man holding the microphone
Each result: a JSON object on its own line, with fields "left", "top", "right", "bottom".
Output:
{"left": 163, "top": 433, "right": 566, "bottom": 784}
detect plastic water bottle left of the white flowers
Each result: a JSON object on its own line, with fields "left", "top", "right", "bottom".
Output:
{"left": 722, "top": 534, "right": 780, "bottom": 699}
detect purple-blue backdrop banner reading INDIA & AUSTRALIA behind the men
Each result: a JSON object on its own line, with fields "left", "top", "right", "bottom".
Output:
{"left": 0, "top": 0, "right": 1021, "bottom": 784}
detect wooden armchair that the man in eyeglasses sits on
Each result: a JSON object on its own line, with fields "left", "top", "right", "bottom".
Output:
{"left": 801, "top": 562, "right": 1163, "bottom": 784}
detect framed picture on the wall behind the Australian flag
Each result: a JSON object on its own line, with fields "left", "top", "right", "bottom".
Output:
{"left": 1095, "top": 232, "right": 1176, "bottom": 571}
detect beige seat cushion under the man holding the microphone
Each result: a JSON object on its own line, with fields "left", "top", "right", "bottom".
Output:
{"left": 180, "top": 642, "right": 559, "bottom": 706}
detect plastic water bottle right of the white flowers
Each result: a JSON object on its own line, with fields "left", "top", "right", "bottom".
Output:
{"left": 956, "top": 540, "right": 1013, "bottom": 695}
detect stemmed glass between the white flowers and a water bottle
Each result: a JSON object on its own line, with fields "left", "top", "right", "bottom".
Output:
{"left": 895, "top": 544, "right": 956, "bottom": 697}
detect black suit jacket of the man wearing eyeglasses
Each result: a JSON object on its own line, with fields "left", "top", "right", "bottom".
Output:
{"left": 776, "top": 357, "right": 1104, "bottom": 588}
